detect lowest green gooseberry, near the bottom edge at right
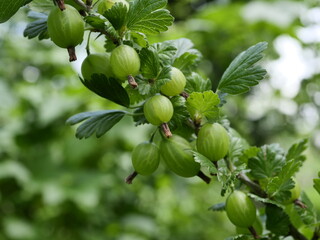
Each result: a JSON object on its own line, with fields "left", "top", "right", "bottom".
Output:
{"left": 226, "top": 190, "right": 256, "bottom": 228}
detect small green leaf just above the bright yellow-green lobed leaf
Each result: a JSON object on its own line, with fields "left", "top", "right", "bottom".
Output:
{"left": 184, "top": 72, "right": 212, "bottom": 94}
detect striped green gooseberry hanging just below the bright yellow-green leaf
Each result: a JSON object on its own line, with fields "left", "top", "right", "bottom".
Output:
{"left": 197, "top": 123, "right": 230, "bottom": 161}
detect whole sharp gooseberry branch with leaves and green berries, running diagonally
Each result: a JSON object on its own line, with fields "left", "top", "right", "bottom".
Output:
{"left": 0, "top": 0, "right": 320, "bottom": 240}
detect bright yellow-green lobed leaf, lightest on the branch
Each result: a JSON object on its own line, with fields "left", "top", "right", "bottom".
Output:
{"left": 187, "top": 90, "right": 220, "bottom": 120}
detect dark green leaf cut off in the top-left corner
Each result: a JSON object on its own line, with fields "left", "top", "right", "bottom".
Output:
{"left": 0, "top": 0, "right": 30, "bottom": 23}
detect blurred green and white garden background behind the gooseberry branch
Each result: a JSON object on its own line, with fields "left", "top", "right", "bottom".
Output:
{"left": 0, "top": 0, "right": 320, "bottom": 240}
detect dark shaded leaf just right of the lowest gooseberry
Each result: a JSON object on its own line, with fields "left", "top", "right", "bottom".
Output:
{"left": 266, "top": 204, "right": 290, "bottom": 236}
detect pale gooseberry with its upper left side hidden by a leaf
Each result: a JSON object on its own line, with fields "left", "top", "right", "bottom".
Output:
{"left": 161, "top": 67, "right": 187, "bottom": 96}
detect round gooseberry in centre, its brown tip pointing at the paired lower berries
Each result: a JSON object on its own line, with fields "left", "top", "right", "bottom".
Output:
{"left": 143, "top": 95, "right": 173, "bottom": 126}
